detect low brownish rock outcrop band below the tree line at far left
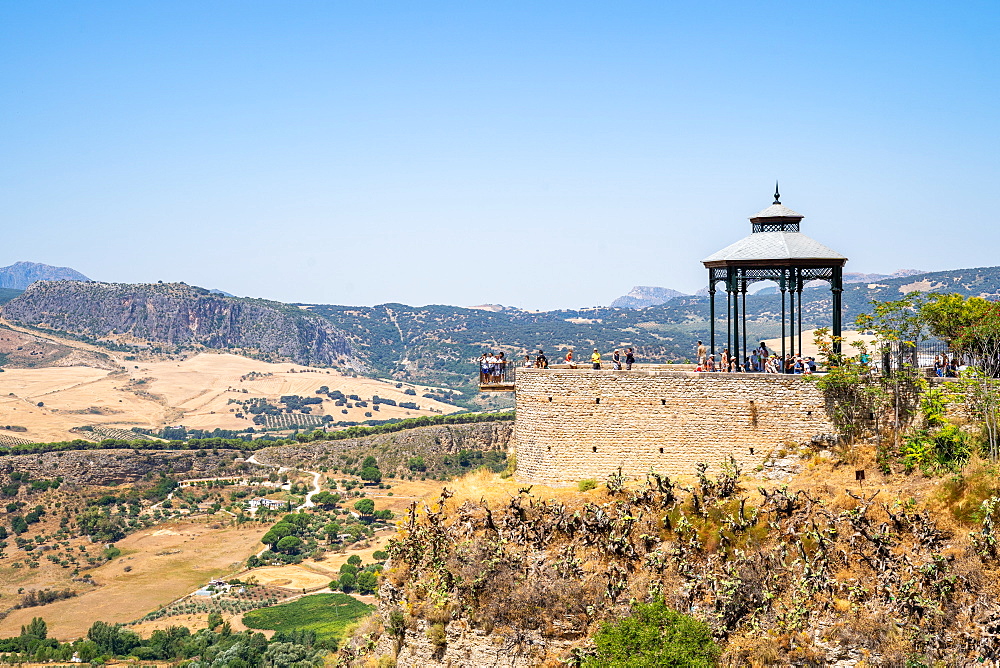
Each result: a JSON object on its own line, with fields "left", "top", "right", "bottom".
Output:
{"left": 0, "top": 449, "right": 264, "bottom": 485}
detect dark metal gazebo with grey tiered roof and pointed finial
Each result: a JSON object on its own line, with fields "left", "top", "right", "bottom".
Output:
{"left": 702, "top": 184, "right": 847, "bottom": 364}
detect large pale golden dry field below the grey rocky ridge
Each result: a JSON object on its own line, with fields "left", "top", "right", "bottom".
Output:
{"left": 0, "top": 324, "right": 457, "bottom": 442}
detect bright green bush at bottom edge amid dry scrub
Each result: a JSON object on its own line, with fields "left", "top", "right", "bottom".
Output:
{"left": 583, "top": 601, "right": 720, "bottom": 668}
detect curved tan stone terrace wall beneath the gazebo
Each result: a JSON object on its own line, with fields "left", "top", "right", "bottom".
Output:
{"left": 514, "top": 369, "right": 835, "bottom": 484}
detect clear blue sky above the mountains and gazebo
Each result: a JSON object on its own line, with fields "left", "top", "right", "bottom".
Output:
{"left": 0, "top": 0, "right": 1000, "bottom": 308}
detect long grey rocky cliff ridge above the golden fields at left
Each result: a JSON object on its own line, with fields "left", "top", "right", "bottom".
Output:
{"left": 3, "top": 281, "right": 364, "bottom": 369}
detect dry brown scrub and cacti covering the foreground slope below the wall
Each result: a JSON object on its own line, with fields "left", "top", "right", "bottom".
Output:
{"left": 344, "top": 446, "right": 1000, "bottom": 665}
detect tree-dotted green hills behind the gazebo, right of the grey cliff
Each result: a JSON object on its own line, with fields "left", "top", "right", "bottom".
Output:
{"left": 308, "top": 267, "right": 1000, "bottom": 389}
